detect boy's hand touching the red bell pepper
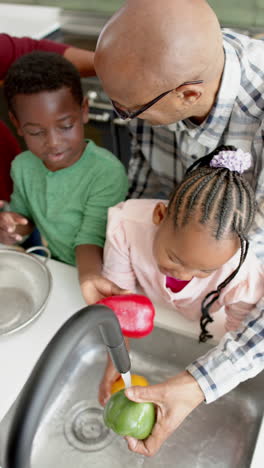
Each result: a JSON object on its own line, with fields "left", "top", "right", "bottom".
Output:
{"left": 81, "top": 275, "right": 131, "bottom": 304}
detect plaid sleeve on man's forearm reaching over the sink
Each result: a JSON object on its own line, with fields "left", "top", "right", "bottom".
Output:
{"left": 187, "top": 299, "right": 264, "bottom": 403}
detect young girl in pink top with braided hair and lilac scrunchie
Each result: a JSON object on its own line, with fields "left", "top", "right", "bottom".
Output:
{"left": 96, "top": 147, "right": 264, "bottom": 401}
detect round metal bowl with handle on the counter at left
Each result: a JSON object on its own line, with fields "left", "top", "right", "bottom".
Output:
{"left": 0, "top": 247, "right": 52, "bottom": 335}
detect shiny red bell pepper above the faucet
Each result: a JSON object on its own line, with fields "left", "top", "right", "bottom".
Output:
{"left": 97, "top": 294, "right": 155, "bottom": 338}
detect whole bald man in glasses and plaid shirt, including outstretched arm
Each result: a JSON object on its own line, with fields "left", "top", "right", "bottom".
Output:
{"left": 94, "top": 0, "right": 264, "bottom": 456}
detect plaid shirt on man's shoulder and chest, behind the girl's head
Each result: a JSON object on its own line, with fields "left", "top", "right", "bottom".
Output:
{"left": 129, "top": 30, "right": 264, "bottom": 261}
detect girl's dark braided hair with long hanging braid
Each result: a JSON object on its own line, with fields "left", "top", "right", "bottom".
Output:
{"left": 168, "top": 145, "right": 255, "bottom": 342}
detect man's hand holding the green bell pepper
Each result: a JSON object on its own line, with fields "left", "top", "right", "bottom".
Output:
{"left": 125, "top": 371, "right": 204, "bottom": 457}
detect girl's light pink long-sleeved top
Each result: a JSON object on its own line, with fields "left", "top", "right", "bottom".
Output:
{"left": 103, "top": 200, "right": 264, "bottom": 330}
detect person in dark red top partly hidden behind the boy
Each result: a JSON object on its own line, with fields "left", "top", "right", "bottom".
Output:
{"left": 0, "top": 34, "right": 95, "bottom": 201}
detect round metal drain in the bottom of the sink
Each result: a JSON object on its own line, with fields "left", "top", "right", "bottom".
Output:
{"left": 64, "top": 401, "right": 114, "bottom": 452}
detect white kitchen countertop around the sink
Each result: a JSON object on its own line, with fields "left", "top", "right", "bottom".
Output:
{"left": 0, "top": 254, "right": 264, "bottom": 468}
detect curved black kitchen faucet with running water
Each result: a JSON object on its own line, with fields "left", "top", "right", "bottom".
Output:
{"left": 3, "top": 304, "right": 130, "bottom": 468}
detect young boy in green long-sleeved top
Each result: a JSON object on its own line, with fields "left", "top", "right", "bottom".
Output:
{"left": 0, "top": 52, "right": 128, "bottom": 303}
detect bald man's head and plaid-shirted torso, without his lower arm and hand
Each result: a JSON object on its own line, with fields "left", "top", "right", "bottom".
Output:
{"left": 94, "top": 0, "right": 264, "bottom": 261}
